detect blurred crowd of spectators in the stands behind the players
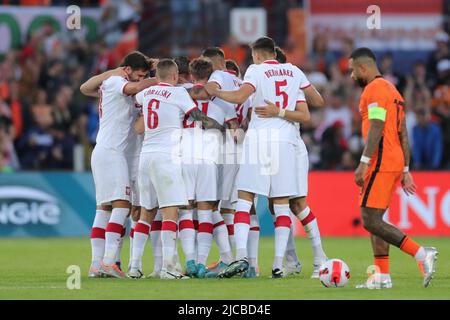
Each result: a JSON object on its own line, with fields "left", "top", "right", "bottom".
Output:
{"left": 0, "top": 0, "right": 450, "bottom": 172}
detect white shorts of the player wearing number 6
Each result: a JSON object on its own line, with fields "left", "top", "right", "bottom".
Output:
{"left": 139, "top": 153, "right": 188, "bottom": 209}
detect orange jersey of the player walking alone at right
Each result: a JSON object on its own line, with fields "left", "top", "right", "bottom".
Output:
{"left": 359, "top": 77, "right": 405, "bottom": 172}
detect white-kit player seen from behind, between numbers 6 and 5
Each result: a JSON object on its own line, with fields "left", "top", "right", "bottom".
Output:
{"left": 180, "top": 58, "right": 238, "bottom": 278}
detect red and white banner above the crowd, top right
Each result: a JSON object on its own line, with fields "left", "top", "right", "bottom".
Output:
{"left": 309, "top": 0, "right": 443, "bottom": 50}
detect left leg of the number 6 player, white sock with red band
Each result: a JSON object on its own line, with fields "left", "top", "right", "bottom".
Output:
{"left": 128, "top": 207, "right": 157, "bottom": 279}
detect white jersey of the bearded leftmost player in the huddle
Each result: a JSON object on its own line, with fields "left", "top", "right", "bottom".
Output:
{"left": 97, "top": 76, "right": 135, "bottom": 152}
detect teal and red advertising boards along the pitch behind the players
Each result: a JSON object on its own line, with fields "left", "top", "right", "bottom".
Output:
{"left": 0, "top": 172, "right": 450, "bottom": 237}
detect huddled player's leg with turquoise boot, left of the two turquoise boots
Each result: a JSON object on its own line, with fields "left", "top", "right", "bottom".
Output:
{"left": 178, "top": 201, "right": 197, "bottom": 277}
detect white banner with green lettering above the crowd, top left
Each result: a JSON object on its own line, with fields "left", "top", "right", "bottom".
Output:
{"left": 0, "top": 5, "right": 100, "bottom": 54}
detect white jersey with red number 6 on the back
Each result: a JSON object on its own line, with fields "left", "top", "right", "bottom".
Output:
{"left": 136, "top": 83, "right": 197, "bottom": 155}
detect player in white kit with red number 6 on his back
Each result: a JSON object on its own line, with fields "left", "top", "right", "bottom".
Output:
{"left": 136, "top": 59, "right": 224, "bottom": 279}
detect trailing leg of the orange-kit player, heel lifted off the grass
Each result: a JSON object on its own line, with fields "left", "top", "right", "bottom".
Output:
{"left": 360, "top": 172, "right": 438, "bottom": 287}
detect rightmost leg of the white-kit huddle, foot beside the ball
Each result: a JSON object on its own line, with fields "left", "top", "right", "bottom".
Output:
{"left": 289, "top": 197, "right": 327, "bottom": 278}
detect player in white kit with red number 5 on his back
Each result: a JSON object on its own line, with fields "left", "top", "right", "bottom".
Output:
{"left": 206, "top": 37, "right": 312, "bottom": 278}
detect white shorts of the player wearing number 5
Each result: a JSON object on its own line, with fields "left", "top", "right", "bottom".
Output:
{"left": 237, "top": 142, "right": 299, "bottom": 198}
